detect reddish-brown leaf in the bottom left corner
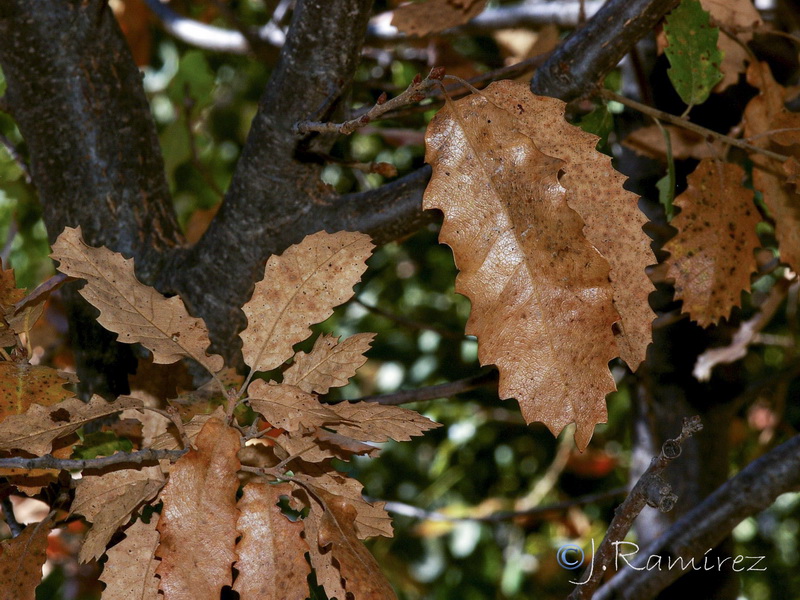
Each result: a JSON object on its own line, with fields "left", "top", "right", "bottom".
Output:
{"left": 0, "top": 518, "right": 52, "bottom": 600}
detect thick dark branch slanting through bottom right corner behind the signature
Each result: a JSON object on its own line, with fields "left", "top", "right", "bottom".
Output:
{"left": 593, "top": 435, "right": 800, "bottom": 600}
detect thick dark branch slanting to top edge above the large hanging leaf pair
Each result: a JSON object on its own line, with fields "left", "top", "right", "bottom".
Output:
{"left": 531, "top": 0, "right": 678, "bottom": 102}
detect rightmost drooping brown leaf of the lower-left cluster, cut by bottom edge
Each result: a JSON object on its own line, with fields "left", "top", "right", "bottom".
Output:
{"left": 304, "top": 489, "right": 397, "bottom": 600}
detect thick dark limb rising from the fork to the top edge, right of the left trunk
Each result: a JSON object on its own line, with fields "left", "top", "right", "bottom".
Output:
{"left": 169, "top": 0, "right": 374, "bottom": 360}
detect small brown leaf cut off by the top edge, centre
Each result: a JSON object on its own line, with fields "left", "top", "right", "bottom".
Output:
{"left": 392, "top": 0, "right": 486, "bottom": 36}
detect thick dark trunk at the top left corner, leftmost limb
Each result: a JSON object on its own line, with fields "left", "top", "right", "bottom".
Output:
{"left": 0, "top": 0, "right": 180, "bottom": 281}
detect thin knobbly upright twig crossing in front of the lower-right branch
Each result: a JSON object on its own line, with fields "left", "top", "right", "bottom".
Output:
{"left": 569, "top": 417, "right": 703, "bottom": 600}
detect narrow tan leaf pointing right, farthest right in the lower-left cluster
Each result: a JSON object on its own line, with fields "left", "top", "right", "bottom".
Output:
{"left": 328, "top": 402, "right": 441, "bottom": 442}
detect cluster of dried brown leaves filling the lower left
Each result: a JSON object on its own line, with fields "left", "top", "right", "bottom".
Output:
{"left": 0, "top": 229, "right": 437, "bottom": 600}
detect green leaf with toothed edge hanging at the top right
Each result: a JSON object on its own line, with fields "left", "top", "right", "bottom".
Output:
{"left": 664, "top": 0, "right": 722, "bottom": 107}
